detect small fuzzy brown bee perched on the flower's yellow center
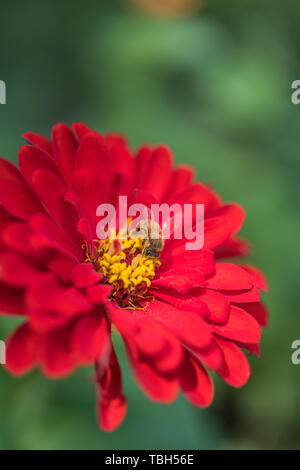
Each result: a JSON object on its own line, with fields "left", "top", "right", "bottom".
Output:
{"left": 131, "top": 220, "right": 165, "bottom": 258}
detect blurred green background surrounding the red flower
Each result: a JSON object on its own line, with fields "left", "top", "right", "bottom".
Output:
{"left": 0, "top": 0, "right": 300, "bottom": 449}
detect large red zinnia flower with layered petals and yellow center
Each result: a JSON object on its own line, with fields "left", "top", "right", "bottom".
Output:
{"left": 0, "top": 123, "right": 267, "bottom": 431}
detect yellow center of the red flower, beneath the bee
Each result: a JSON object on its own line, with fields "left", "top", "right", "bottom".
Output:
{"left": 84, "top": 227, "right": 161, "bottom": 309}
